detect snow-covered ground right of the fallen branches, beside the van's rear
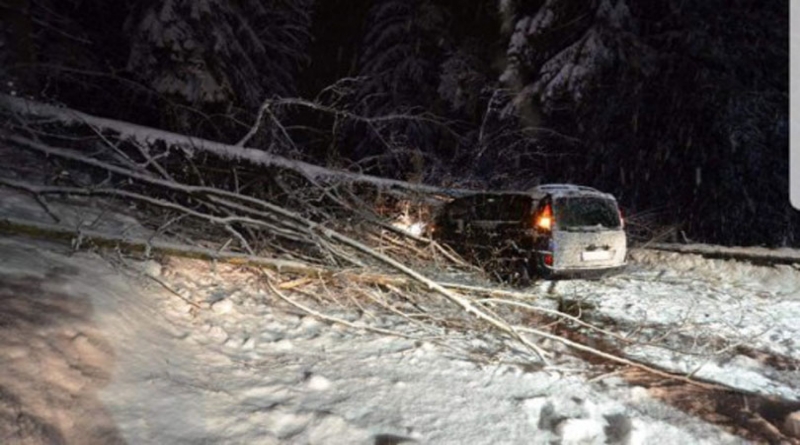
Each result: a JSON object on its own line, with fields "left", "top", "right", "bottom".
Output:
{"left": 540, "top": 250, "right": 800, "bottom": 401}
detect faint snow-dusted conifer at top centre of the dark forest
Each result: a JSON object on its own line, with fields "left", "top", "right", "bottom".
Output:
{"left": 340, "top": 0, "right": 450, "bottom": 175}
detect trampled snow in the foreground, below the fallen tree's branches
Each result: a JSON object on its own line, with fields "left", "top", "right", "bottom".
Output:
{"left": 0, "top": 234, "right": 772, "bottom": 444}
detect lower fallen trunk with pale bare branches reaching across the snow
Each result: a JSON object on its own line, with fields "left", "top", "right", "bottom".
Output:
{"left": 0, "top": 210, "right": 721, "bottom": 389}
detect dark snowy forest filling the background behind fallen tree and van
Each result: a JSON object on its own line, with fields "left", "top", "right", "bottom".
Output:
{"left": 0, "top": 0, "right": 800, "bottom": 246}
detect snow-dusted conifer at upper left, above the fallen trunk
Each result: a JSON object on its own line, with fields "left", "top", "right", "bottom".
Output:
{"left": 126, "top": 0, "right": 312, "bottom": 134}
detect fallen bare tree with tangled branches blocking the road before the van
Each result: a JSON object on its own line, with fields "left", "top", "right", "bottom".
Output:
{"left": 0, "top": 96, "right": 764, "bottom": 386}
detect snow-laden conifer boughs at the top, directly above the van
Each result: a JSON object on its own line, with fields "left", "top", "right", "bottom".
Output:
{"left": 501, "top": 0, "right": 645, "bottom": 111}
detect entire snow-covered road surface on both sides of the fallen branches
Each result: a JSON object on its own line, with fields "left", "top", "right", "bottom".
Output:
{"left": 0, "top": 234, "right": 800, "bottom": 444}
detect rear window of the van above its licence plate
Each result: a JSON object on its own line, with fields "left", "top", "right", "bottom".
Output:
{"left": 554, "top": 196, "right": 622, "bottom": 230}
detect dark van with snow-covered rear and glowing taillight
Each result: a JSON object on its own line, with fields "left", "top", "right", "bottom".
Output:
{"left": 434, "top": 184, "right": 627, "bottom": 277}
